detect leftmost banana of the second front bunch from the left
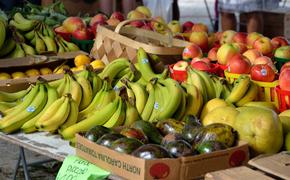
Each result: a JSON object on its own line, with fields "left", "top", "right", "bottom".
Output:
{"left": 35, "top": 96, "right": 66, "bottom": 129}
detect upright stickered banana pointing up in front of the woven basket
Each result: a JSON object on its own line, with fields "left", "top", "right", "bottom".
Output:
{"left": 137, "top": 48, "right": 168, "bottom": 82}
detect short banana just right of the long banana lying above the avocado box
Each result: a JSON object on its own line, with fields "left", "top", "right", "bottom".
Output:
{"left": 103, "top": 98, "right": 126, "bottom": 128}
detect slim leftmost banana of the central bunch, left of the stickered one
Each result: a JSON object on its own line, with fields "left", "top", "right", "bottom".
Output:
{"left": 141, "top": 83, "right": 155, "bottom": 121}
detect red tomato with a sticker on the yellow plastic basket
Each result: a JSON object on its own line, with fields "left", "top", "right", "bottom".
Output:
{"left": 251, "top": 64, "right": 275, "bottom": 82}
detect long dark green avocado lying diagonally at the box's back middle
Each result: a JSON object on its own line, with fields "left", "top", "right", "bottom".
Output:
{"left": 130, "top": 120, "right": 163, "bottom": 144}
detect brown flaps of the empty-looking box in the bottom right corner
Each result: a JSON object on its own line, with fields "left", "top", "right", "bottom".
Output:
{"left": 205, "top": 152, "right": 290, "bottom": 180}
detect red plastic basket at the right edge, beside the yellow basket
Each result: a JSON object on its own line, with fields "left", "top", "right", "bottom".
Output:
{"left": 275, "top": 86, "right": 290, "bottom": 112}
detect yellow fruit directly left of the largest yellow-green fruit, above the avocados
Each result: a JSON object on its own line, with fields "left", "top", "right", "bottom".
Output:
{"left": 202, "top": 106, "right": 239, "bottom": 127}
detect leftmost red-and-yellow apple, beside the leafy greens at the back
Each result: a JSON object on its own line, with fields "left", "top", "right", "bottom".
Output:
{"left": 62, "top": 17, "right": 86, "bottom": 33}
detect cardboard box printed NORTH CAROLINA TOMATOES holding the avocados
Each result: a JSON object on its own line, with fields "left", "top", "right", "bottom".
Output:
{"left": 76, "top": 135, "right": 249, "bottom": 180}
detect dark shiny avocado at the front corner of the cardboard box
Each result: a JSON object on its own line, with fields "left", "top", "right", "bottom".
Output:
{"left": 131, "top": 144, "right": 172, "bottom": 159}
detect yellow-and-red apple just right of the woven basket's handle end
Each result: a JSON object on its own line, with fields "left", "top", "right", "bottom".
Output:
{"left": 189, "top": 31, "right": 208, "bottom": 52}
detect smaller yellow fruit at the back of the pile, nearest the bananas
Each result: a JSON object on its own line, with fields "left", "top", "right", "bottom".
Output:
{"left": 200, "top": 98, "right": 228, "bottom": 120}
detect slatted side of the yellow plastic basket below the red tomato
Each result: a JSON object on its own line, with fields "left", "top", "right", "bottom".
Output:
{"left": 252, "top": 80, "right": 279, "bottom": 108}
